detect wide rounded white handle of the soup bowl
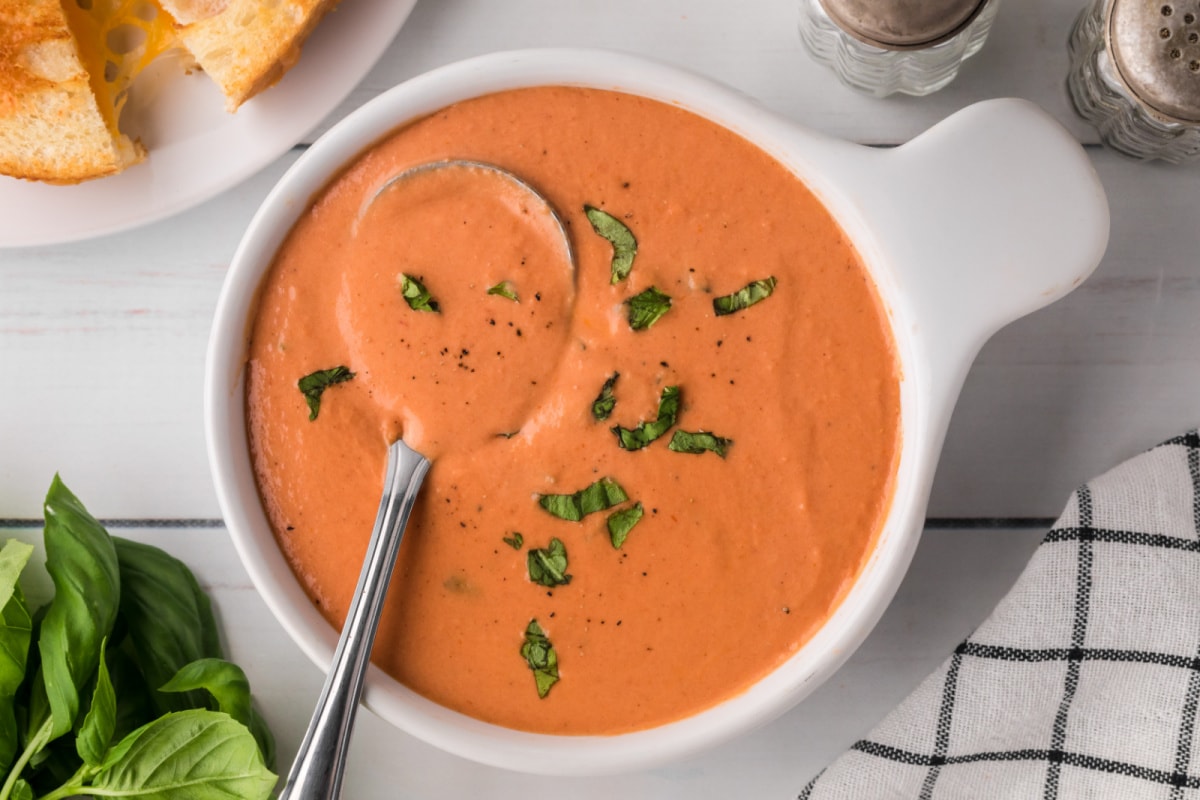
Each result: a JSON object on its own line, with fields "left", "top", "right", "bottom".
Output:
{"left": 811, "top": 100, "right": 1109, "bottom": 417}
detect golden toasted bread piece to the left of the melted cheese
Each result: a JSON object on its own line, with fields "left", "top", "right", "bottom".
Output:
{"left": 0, "top": 0, "right": 145, "bottom": 184}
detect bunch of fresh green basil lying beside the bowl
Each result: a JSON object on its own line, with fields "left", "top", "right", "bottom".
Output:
{"left": 0, "top": 477, "right": 276, "bottom": 800}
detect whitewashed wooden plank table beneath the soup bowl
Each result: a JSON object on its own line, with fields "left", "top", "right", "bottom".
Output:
{"left": 0, "top": 0, "right": 1200, "bottom": 800}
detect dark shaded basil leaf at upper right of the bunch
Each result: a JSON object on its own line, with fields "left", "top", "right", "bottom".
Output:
{"left": 114, "top": 539, "right": 223, "bottom": 712}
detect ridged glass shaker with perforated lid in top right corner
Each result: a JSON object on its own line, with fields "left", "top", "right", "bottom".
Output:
{"left": 1067, "top": 0, "right": 1200, "bottom": 164}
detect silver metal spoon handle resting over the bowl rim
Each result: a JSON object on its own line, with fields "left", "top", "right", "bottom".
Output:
{"left": 278, "top": 440, "right": 430, "bottom": 800}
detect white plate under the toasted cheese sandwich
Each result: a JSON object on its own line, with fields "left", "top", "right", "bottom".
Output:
{"left": 0, "top": 0, "right": 416, "bottom": 247}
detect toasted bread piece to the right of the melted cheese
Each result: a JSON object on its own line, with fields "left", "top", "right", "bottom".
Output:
{"left": 158, "top": 0, "right": 338, "bottom": 112}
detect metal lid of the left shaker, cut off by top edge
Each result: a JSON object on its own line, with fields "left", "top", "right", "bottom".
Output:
{"left": 821, "top": 0, "right": 988, "bottom": 50}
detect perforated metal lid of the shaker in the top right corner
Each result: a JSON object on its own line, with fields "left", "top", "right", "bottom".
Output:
{"left": 1106, "top": 0, "right": 1200, "bottom": 122}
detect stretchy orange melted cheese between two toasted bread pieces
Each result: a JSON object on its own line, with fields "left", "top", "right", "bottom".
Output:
{"left": 62, "top": 0, "right": 178, "bottom": 137}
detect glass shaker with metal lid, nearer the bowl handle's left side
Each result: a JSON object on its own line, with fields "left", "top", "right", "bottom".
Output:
{"left": 800, "top": 0, "right": 998, "bottom": 97}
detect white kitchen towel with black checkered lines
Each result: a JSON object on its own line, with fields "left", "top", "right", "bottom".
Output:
{"left": 799, "top": 431, "right": 1200, "bottom": 800}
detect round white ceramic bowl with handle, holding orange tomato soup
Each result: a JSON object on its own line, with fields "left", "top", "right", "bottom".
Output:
{"left": 205, "top": 49, "right": 1109, "bottom": 775}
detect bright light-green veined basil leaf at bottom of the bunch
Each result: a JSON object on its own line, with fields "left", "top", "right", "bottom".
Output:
{"left": 89, "top": 709, "right": 276, "bottom": 800}
